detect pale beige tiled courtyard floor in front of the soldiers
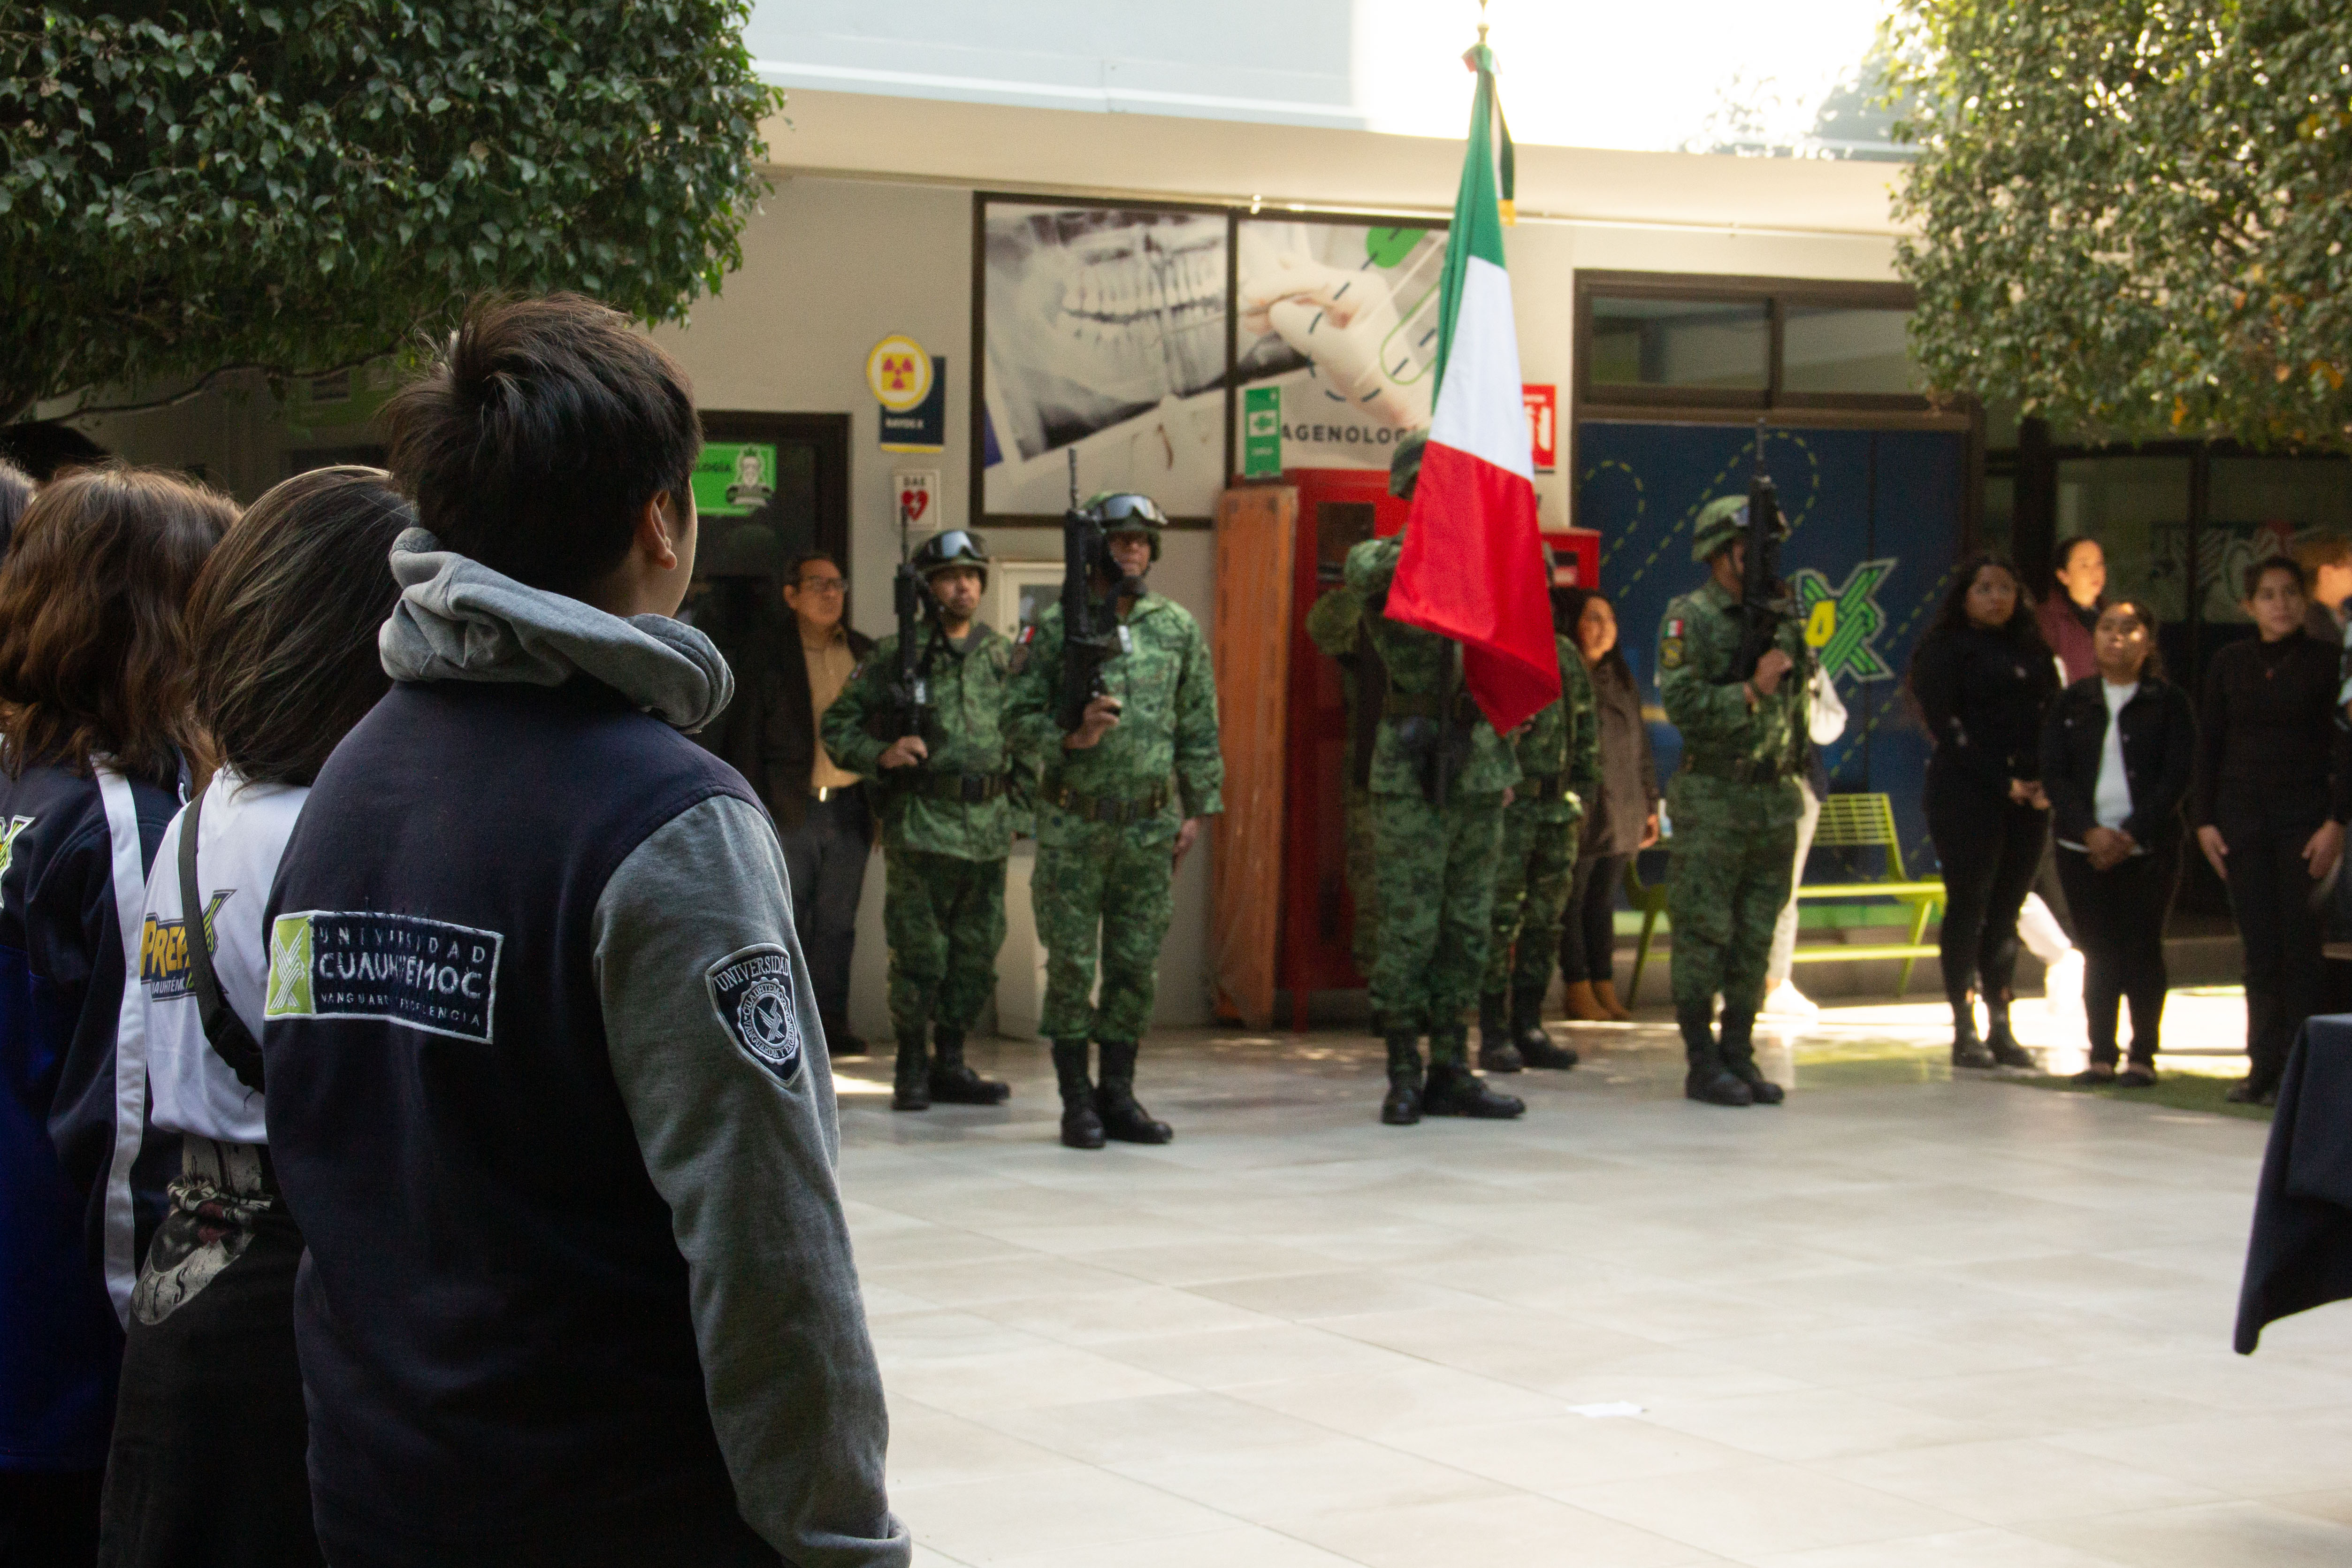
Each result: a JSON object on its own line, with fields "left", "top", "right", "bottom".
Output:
{"left": 842, "top": 999, "right": 2352, "bottom": 1568}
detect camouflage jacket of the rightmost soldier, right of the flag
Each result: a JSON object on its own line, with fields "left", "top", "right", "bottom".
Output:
{"left": 1658, "top": 578, "right": 1811, "bottom": 778}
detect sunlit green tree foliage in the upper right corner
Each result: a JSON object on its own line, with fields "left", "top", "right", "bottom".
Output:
{"left": 1889, "top": 0, "right": 2352, "bottom": 449}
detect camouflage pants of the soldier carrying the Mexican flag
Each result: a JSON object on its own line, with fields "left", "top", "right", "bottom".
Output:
{"left": 1371, "top": 795, "right": 1503, "bottom": 1037}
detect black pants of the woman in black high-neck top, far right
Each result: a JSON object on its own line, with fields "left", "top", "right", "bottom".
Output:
{"left": 2213, "top": 790, "right": 2329, "bottom": 1088}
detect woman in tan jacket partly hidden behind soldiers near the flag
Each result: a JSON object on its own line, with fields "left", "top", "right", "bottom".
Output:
{"left": 1552, "top": 588, "right": 1658, "bottom": 1023}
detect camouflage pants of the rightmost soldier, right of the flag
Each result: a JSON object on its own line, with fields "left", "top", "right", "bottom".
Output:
{"left": 1665, "top": 773, "right": 1802, "bottom": 1016}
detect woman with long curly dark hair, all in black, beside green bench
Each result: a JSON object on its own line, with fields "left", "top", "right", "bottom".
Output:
{"left": 1910, "top": 555, "right": 2058, "bottom": 1067}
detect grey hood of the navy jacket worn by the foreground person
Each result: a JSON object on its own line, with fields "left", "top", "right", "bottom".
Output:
{"left": 376, "top": 529, "right": 734, "bottom": 734}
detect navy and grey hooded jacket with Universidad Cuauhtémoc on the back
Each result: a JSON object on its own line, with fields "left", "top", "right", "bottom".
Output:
{"left": 263, "top": 529, "right": 910, "bottom": 1568}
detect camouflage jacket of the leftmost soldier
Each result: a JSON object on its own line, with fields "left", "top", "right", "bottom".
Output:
{"left": 823, "top": 625, "right": 1035, "bottom": 860}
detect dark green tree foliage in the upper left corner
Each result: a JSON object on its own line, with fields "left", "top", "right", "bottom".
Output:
{"left": 0, "top": 0, "right": 783, "bottom": 423}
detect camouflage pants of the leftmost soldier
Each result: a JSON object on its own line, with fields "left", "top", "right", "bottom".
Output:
{"left": 882, "top": 849, "right": 1004, "bottom": 1034}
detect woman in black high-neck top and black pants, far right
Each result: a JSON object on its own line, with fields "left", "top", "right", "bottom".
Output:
{"left": 2192, "top": 557, "right": 2352, "bottom": 1105}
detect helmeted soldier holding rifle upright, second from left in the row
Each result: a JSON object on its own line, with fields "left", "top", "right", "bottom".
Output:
{"left": 1004, "top": 494, "right": 1225, "bottom": 1149}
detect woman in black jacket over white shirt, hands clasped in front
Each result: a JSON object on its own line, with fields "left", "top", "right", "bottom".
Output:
{"left": 2041, "top": 599, "right": 2197, "bottom": 1088}
